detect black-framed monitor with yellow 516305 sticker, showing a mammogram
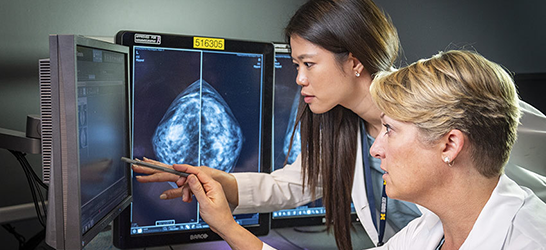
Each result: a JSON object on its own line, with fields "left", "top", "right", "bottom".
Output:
{"left": 114, "top": 31, "right": 274, "bottom": 248}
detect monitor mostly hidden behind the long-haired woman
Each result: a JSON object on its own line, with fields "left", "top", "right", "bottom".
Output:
{"left": 271, "top": 43, "right": 356, "bottom": 230}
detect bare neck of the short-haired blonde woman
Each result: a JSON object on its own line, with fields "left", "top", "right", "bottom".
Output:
{"left": 426, "top": 171, "right": 499, "bottom": 250}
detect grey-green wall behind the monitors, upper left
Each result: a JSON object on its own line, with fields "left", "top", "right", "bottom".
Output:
{"left": 0, "top": 0, "right": 304, "bottom": 246}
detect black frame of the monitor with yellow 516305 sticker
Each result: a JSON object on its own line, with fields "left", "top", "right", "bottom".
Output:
{"left": 113, "top": 30, "right": 274, "bottom": 249}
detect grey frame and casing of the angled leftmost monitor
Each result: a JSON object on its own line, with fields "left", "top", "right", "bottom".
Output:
{"left": 41, "top": 35, "right": 132, "bottom": 249}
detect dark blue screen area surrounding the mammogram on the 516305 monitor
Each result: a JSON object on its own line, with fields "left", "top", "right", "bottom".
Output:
{"left": 132, "top": 47, "right": 262, "bottom": 229}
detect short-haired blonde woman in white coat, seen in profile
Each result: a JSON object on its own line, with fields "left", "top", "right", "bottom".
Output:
{"left": 370, "top": 51, "right": 546, "bottom": 250}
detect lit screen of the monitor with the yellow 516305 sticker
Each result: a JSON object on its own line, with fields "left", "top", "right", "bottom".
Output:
{"left": 131, "top": 46, "right": 263, "bottom": 234}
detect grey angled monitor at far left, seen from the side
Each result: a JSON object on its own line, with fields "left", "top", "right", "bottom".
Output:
{"left": 40, "top": 35, "right": 131, "bottom": 249}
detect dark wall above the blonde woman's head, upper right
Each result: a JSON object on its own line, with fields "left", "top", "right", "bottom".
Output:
{"left": 375, "top": 0, "right": 546, "bottom": 73}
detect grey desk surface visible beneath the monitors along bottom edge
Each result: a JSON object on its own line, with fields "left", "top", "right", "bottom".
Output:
{"left": 85, "top": 223, "right": 373, "bottom": 250}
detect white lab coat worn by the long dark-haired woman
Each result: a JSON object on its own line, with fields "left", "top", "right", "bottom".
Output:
{"left": 233, "top": 102, "right": 546, "bottom": 248}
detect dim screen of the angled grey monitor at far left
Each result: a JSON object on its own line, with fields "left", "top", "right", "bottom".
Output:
{"left": 76, "top": 46, "right": 129, "bottom": 233}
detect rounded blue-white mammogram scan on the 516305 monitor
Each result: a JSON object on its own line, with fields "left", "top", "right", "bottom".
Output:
{"left": 152, "top": 80, "right": 244, "bottom": 172}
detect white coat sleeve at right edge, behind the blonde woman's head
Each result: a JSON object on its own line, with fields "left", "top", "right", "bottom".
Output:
{"left": 505, "top": 101, "right": 546, "bottom": 201}
